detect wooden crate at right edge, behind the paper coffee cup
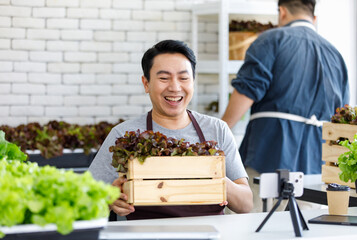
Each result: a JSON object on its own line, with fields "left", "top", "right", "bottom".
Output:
{"left": 322, "top": 123, "right": 357, "bottom": 188}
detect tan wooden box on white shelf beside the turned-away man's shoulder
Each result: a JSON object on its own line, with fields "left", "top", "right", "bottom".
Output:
{"left": 229, "top": 32, "right": 258, "bottom": 60}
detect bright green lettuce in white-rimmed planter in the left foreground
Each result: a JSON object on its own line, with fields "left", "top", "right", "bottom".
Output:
{"left": 0, "top": 131, "right": 120, "bottom": 240}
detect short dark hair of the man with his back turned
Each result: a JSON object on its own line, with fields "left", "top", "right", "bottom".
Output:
{"left": 278, "top": 0, "right": 316, "bottom": 18}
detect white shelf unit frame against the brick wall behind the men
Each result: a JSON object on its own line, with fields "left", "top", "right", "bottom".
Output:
{"left": 192, "top": 0, "right": 278, "bottom": 117}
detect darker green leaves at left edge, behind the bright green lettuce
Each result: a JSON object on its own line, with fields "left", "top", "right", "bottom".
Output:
{"left": 0, "top": 131, "right": 27, "bottom": 161}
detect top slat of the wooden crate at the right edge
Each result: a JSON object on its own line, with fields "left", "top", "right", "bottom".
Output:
{"left": 322, "top": 122, "right": 357, "bottom": 141}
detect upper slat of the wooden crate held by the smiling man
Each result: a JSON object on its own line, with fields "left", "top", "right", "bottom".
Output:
{"left": 127, "top": 156, "right": 226, "bottom": 179}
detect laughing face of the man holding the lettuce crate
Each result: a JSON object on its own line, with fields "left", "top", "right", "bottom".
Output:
{"left": 142, "top": 53, "right": 193, "bottom": 118}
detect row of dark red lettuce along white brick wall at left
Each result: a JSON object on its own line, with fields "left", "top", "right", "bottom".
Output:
{"left": 0, "top": 119, "right": 124, "bottom": 159}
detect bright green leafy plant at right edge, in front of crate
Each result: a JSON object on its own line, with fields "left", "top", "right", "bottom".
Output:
{"left": 338, "top": 134, "right": 357, "bottom": 182}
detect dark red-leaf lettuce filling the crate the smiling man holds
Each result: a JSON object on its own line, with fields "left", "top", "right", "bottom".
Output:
{"left": 109, "top": 130, "right": 224, "bottom": 173}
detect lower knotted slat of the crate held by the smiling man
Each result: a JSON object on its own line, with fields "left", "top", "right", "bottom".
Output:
{"left": 124, "top": 178, "right": 227, "bottom": 206}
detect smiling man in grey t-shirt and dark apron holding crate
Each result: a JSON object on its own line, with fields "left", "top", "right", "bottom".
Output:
{"left": 89, "top": 40, "right": 253, "bottom": 220}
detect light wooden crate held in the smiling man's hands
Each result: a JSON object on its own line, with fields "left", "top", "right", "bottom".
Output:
{"left": 123, "top": 156, "right": 226, "bottom": 206}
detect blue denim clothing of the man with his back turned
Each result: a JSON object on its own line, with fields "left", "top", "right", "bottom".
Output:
{"left": 232, "top": 20, "right": 349, "bottom": 174}
